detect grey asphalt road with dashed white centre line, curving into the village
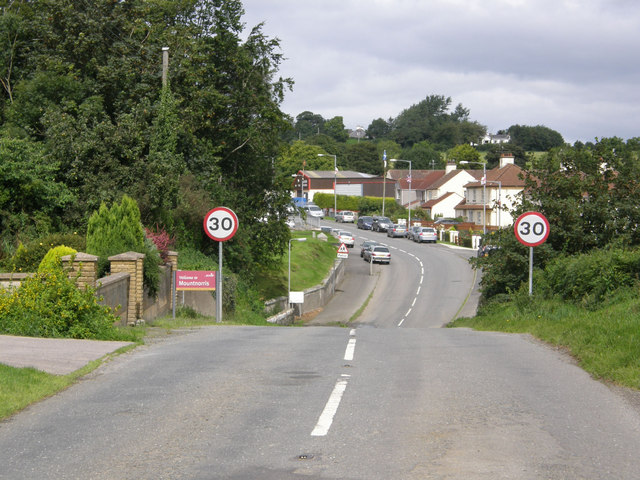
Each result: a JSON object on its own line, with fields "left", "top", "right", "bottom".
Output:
{"left": 0, "top": 223, "right": 640, "bottom": 480}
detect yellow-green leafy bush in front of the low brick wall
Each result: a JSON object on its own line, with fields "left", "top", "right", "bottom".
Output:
{"left": 0, "top": 272, "right": 121, "bottom": 340}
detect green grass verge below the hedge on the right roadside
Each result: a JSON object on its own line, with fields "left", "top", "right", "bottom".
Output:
{"left": 450, "top": 289, "right": 640, "bottom": 389}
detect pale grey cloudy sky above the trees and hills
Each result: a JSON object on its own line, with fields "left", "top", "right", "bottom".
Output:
{"left": 242, "top": 0, "right": 640, "bottom": 143}
